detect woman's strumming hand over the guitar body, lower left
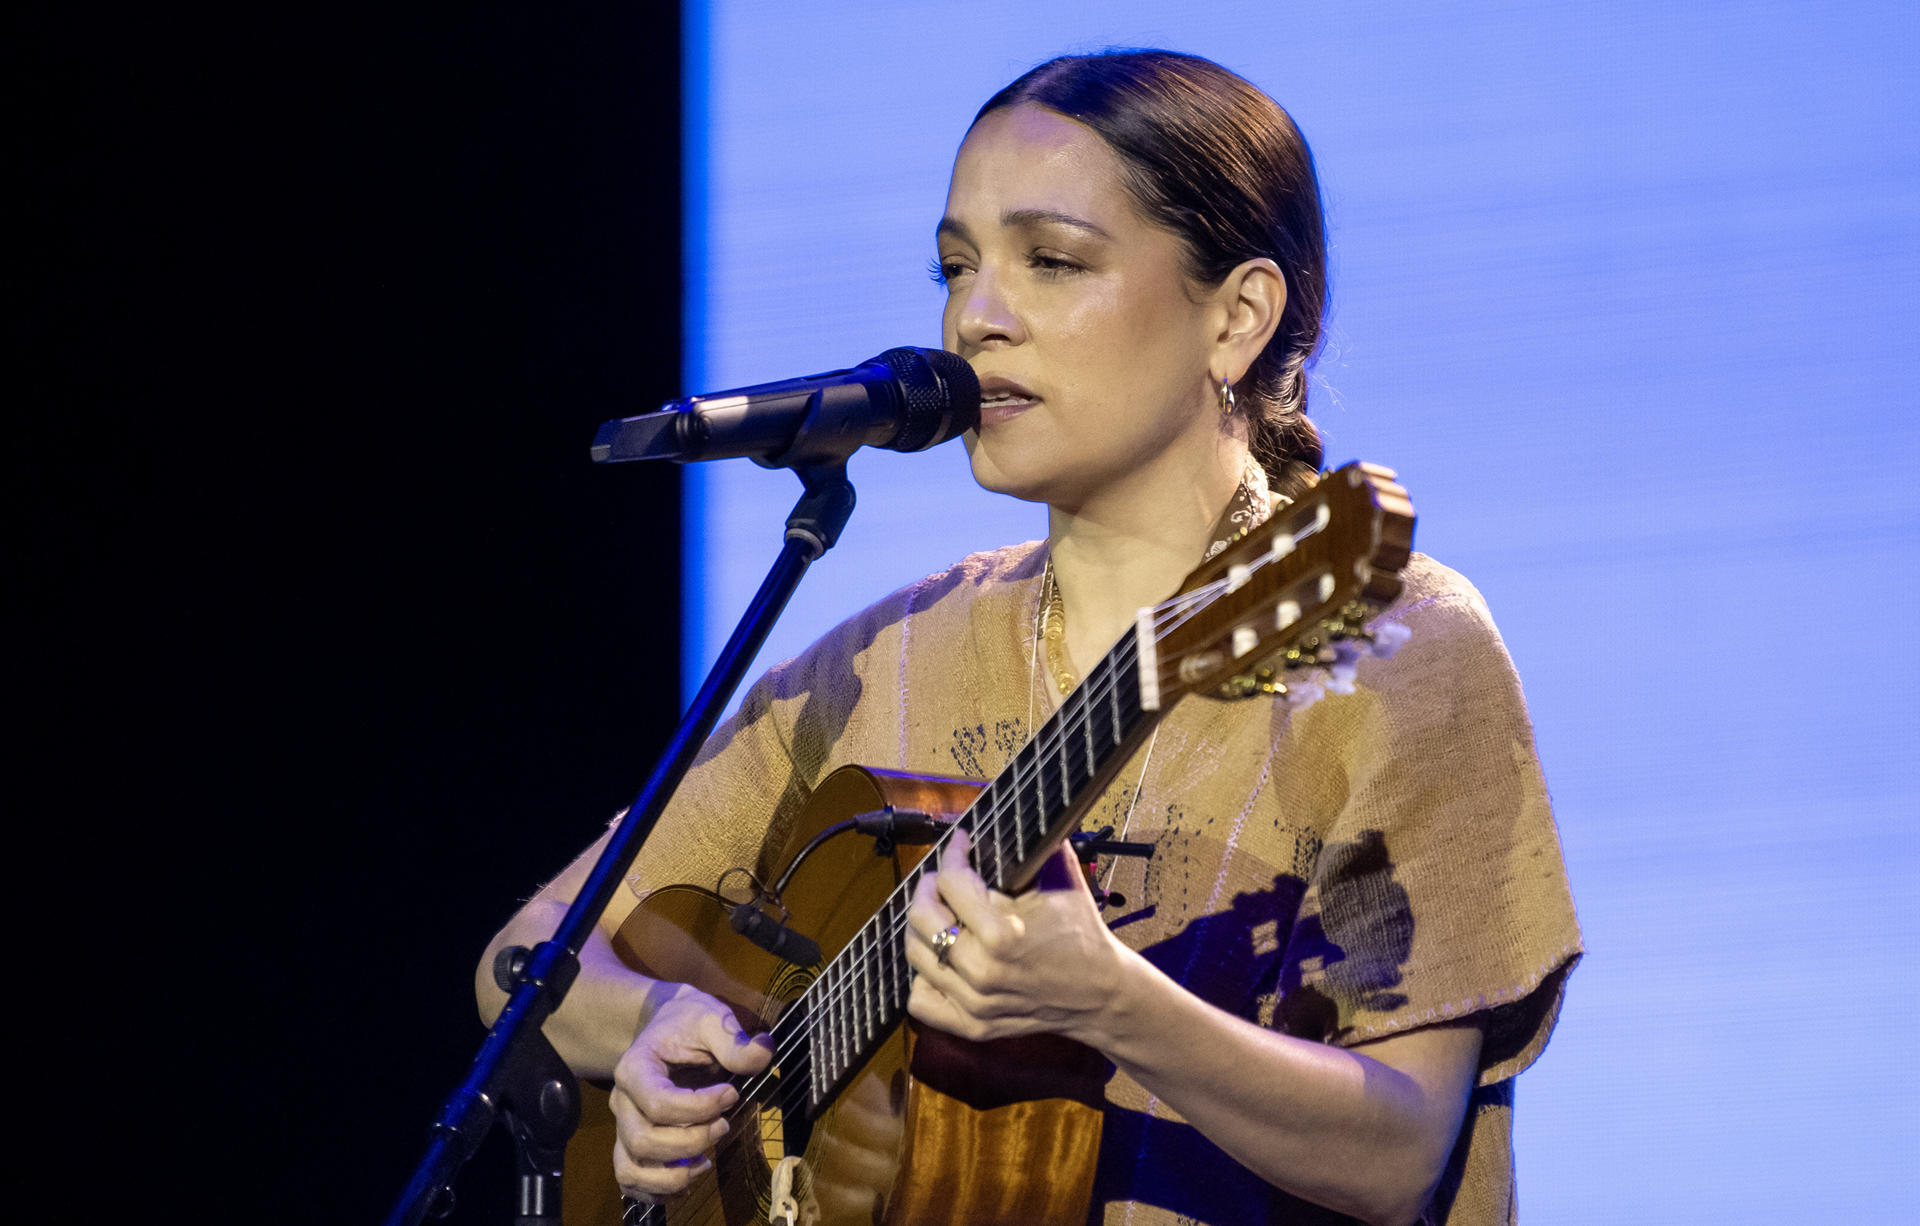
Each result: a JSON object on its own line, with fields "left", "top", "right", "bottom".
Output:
{"left": 612, "top": 984, "right": 774, "bottom": 1201}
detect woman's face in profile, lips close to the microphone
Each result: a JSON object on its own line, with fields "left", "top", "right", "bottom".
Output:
{"left": 939, "top": 106, "right": 1223, "bottom": 510}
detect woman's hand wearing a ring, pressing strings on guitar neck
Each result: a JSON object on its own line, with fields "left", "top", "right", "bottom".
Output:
{"left": 906, "top": 831, "right": 1129, "bottom": 1048}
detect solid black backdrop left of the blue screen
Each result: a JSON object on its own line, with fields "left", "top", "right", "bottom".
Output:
{"left": 8, "top": 4, "right": 682, "bottom": 1222}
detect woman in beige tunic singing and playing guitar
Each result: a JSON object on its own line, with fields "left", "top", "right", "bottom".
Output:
{"left": 480, "top": 52, "right": 1578, "bottom": 1222}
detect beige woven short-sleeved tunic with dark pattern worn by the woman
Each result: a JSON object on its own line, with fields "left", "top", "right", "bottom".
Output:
{"left": 632, "top": 543, "right": 1580, "bottom": 1226}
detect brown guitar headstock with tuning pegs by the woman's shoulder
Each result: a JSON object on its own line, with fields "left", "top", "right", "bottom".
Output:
{"left": 1139, "top": 462, "right": 1413, "bottom": 706}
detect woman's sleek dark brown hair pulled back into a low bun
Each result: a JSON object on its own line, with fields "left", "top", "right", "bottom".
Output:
{"left": 973, "top": 50, "right": 1327, "bottom": 495}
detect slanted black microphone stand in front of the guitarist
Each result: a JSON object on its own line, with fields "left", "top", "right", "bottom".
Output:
{"left": 386, "top": 460, "right": 854, "bottom": 1226}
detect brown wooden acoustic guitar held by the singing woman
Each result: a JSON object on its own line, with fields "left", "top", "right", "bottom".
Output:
{"left": 563, "top": 462, "right": 1413, "bottom": 1226}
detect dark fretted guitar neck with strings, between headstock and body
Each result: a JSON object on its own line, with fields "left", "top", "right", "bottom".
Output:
{"left": 774, "top": 621, "right": 1162, "bottom": 1111}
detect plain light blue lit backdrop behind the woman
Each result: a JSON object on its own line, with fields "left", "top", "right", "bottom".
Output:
{"left": 685, "top": 0, "right": 1920, "bottom": 1224}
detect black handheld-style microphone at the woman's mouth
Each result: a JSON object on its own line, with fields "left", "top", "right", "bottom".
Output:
{"left": 593, "top": 347, "right": 979, "bottom": 468}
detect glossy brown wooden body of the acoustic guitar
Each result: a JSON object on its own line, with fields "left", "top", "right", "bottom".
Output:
{"left": 563, "top": 767, "right": 1108, "bottom": 1226}
